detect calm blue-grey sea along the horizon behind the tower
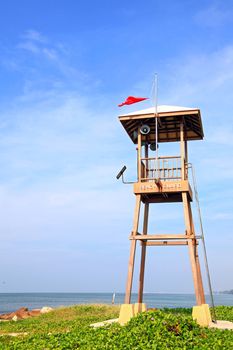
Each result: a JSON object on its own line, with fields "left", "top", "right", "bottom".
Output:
{"left": 0, "top": 293, "right": 233, "bottom": 314}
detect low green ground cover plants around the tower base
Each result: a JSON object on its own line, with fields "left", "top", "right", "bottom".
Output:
{"left": 0, "top": 305, "right": 233, "bottom": 350}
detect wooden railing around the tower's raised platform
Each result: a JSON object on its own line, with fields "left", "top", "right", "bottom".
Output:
{"left": 141, "top": 156, "right": 187, "bottom": 181}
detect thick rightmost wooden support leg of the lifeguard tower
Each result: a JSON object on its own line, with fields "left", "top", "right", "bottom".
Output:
{"left": 182, "top": 192, "right": 205, "bottom": 305}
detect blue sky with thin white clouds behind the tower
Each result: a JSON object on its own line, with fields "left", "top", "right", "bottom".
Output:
{"left": 0, "top": 0, "right": 233, "bottom": 293}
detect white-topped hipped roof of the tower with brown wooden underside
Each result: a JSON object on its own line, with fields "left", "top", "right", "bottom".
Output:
{"left": 119, "top": 105, "right": 204, "bottom": 143}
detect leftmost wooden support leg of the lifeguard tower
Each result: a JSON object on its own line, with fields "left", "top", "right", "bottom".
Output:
{"left": 125, "top": 195, "right": 141, "bottom": 304}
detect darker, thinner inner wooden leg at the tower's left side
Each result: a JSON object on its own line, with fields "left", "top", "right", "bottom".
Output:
{"left": 138, "top": 203, "right": 149, "bottom": 303}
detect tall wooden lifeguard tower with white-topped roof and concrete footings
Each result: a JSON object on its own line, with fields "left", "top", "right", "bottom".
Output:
{"left": 117, "top": 106, "right": 214, "bottom": 323}
